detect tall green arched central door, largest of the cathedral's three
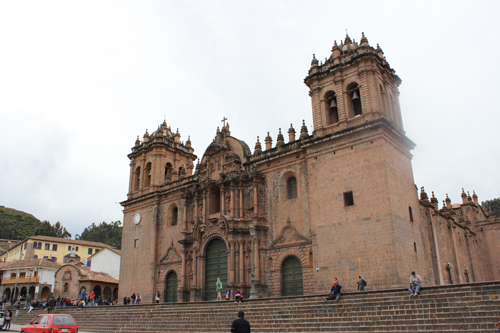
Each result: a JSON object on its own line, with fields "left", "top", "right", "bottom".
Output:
{"left": 205, "top": 238, "right": 227, "bottom": 301}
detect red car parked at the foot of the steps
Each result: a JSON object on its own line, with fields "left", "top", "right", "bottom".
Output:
{"left": 21, "top": 314, "right": 78, "bottom": 333}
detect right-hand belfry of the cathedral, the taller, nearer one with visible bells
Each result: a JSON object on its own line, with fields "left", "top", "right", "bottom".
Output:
{"left": 304, "top": 33, "right": 404, "bottom": 136}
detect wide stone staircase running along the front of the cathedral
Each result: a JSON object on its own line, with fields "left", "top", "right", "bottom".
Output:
{"left": 13, "top": 281, "right": 500, "bottom": 333}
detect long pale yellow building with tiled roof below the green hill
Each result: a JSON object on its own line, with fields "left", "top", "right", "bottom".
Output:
{"left": 0, "top": 236, "right": 114, "bottom": 263}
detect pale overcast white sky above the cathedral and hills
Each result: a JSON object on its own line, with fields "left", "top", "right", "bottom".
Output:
{"left": 0, "top": 0, "right": 500, "bottom": 236}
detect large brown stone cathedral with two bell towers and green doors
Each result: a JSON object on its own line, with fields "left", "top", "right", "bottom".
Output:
{"left": 119, "top": 34, "right": 500, "bottom": 302}
